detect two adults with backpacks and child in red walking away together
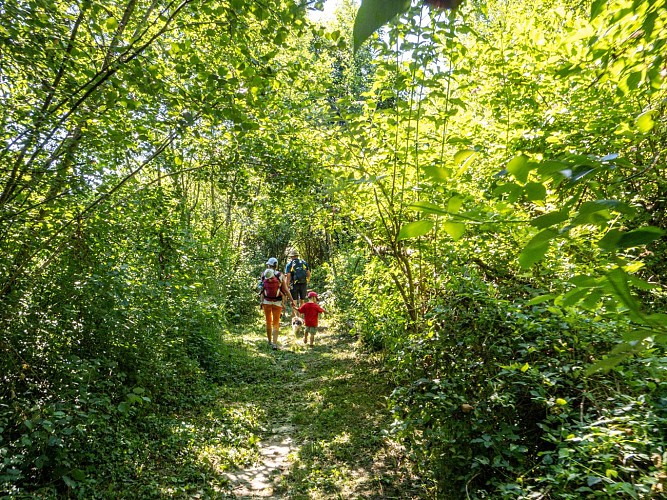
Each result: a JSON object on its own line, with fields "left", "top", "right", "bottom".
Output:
{"left": 259, "top": 250, "right": 326, "bottom": 350}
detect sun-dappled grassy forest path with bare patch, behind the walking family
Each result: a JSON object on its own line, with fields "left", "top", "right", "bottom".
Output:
{"left": 218, "top": 318, "right": 418, "bottom": 499}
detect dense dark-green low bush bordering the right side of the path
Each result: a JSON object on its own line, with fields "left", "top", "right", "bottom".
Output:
{"left": 390, "top": 276, "right": 667, "bottom": 498}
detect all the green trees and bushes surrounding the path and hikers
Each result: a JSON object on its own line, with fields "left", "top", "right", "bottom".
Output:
{"left": 0, "top": 0, "right": 667, "bottom": 498}
